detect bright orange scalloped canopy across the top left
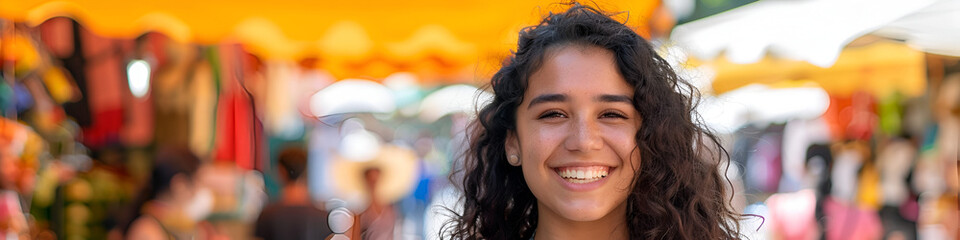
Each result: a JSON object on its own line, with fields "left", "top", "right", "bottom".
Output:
{"left": 0, "top": 0, "right": 660, "bottom": 63}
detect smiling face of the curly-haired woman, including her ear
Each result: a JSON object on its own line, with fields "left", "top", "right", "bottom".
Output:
{"left": 505, "top": 44, "right": 641, "bottom": 222}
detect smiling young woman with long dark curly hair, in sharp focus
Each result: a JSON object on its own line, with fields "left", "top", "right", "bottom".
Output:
{"left": 442, "top": 3, "right": 740, "bottom": 240}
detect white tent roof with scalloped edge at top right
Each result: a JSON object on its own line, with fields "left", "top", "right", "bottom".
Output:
{"left": 671, "top": 0, "right": 960, "bottom": 67}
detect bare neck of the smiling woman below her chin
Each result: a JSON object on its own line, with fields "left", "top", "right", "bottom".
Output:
{"left": 535, "top": 202, "right": 630, "bottom": 240}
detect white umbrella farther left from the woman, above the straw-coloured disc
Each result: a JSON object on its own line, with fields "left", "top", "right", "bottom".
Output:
{"left": 310, "top": 79, "right": 397, "bottom": 117}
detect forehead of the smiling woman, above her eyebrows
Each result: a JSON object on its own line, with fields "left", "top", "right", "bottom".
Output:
{"left": 527, "top": 44, "right": 633, "bottom": 96}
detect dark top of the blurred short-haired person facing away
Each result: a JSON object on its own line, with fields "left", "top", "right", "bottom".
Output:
{"left": 253, "top": 203, "right": 333, "bottom": 240}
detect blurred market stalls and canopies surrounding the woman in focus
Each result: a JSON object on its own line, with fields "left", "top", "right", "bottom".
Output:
{"left": 0, "top": 0, "right": 960, "bottom": 239}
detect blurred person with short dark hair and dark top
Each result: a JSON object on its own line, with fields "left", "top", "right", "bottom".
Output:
{"left": 254, "top": 147, "right": 333, "bottom": 240}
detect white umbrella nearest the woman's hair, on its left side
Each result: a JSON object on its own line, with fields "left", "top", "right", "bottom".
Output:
{"left": 419, "top": 84, "right": 493, "bottom": 122}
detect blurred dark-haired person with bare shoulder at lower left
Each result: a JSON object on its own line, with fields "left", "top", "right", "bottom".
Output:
{"left": 120, "top": 148, "right": 216, "bottom": 240}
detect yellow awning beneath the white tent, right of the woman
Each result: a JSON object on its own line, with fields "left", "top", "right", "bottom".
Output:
{"left": 705, "top": 41, "right": 927, "bottom": 97}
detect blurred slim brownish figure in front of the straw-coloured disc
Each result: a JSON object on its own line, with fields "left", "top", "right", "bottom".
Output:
{"left": 360, "top": 167, "right": 397, "bottom": 240}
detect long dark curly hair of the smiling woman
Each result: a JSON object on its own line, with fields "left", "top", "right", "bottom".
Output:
{"left": 439, "top": 3, "right": 741, "bottom": 239}
